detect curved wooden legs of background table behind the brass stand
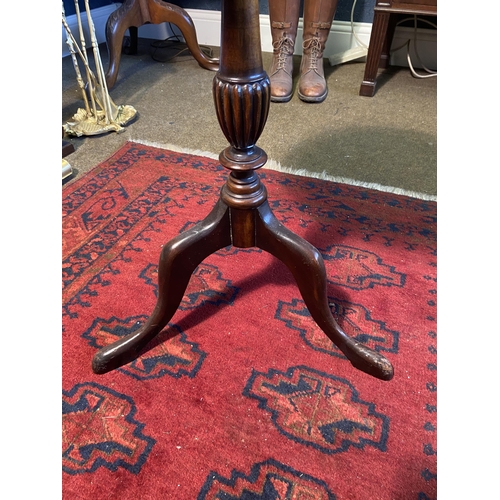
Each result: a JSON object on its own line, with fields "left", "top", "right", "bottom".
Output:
{"left": 106, "top": 0, "right": 218, "bottom": 88}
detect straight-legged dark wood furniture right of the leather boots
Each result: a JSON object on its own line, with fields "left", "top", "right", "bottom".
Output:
{"left": 359, "top": 0, "right": 437, "bottom": 97}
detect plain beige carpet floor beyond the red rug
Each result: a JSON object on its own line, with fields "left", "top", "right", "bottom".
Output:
{"left": 62, "top": 39, "right": 437, "bottom": 199}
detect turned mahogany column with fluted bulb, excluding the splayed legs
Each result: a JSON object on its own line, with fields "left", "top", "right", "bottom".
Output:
{"left": 213, "top": 0, "right": 271, "bottom": 248}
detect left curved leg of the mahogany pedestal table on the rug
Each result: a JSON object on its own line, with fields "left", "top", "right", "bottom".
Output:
{"left": 92, "top": 200, "right": 231, "bottom": 374}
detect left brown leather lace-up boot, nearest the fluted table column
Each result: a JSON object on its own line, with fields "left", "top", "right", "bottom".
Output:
{"left": 268, "top": 0, "right": 300, "bottom": 102}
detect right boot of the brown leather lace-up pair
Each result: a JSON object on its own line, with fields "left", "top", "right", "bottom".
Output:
{"left": 298, "top": 0, "right": 337, "bottom": 102}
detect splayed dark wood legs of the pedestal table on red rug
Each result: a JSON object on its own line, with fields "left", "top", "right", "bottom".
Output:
{"left": 92, "top": 194, "right": 393, "bottom": 380}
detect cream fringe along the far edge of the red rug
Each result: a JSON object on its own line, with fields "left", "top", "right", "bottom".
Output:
{"left": 130, "top": 139, "right": 437, "bottom": 201}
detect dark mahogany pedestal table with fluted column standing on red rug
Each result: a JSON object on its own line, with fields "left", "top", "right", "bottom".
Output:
{"left": 92, "top": 0, "right": 393, "bottom": 380}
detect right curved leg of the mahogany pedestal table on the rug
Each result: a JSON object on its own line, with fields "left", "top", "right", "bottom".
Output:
{"left": 256, "top": 202, "right": 394, "bottom": 380}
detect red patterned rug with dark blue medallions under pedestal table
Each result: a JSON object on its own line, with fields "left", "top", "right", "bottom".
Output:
{"left": 62, "top": 142, "right": 437, "bottom": 500}
